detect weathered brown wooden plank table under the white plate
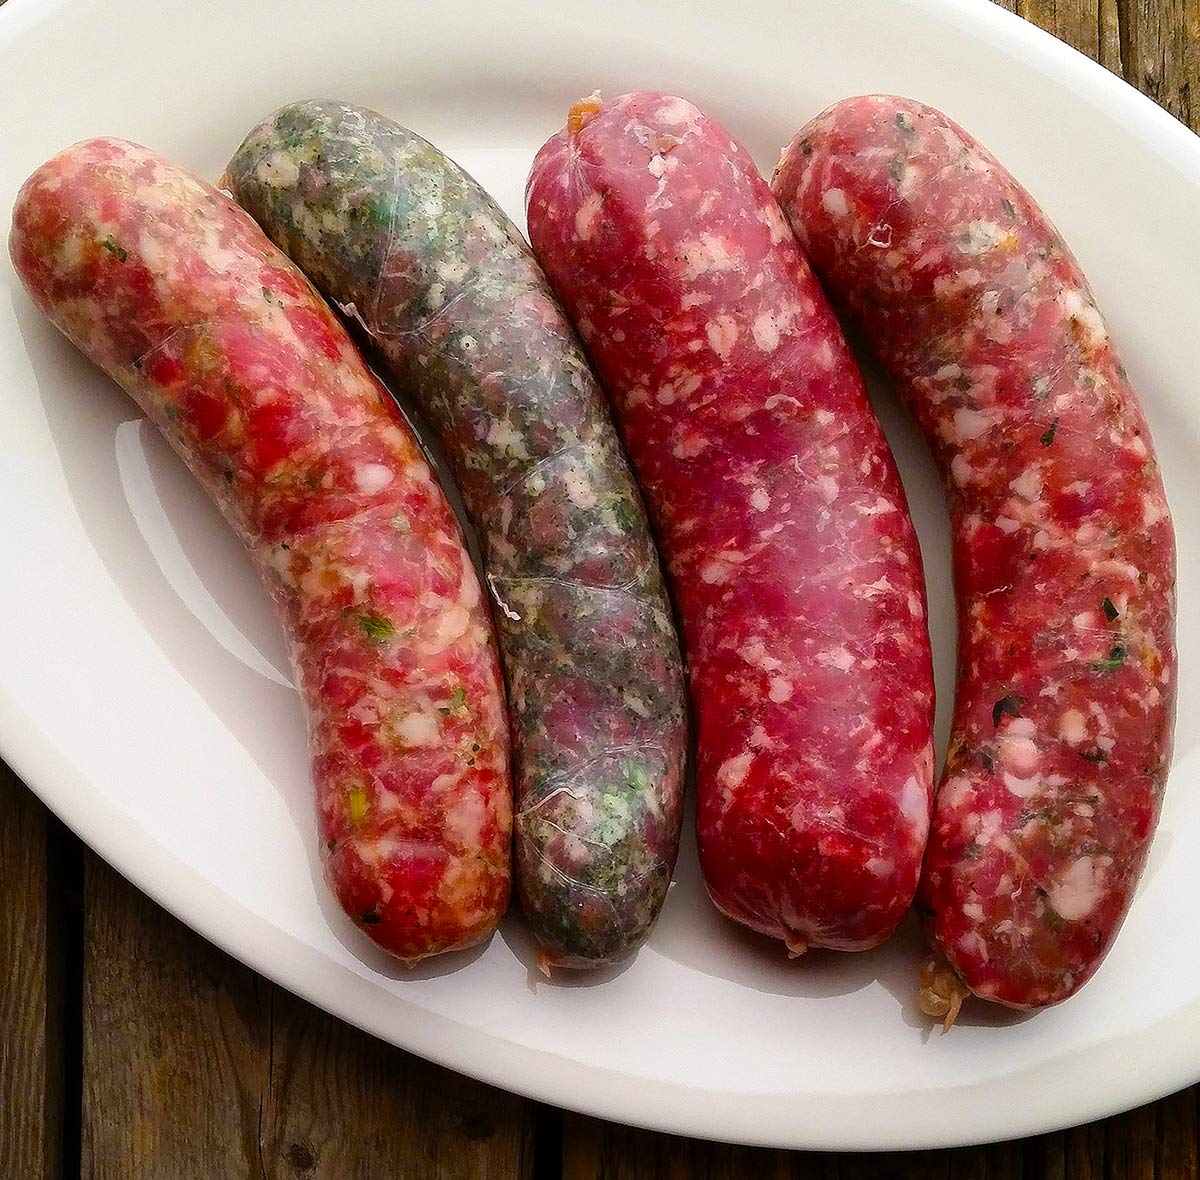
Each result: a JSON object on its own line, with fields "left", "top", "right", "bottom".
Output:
{"left": 0, "top": 0, "right": 1200, "bottom": 1180}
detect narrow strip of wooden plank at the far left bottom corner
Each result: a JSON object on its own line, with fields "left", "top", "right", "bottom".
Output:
{"left": 0, "top": 763, "right": 64, "bottom": 1180}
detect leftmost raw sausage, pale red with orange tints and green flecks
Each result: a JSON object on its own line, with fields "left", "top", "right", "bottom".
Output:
{"left": 10, "top": 139, "right": 511, "bottom": 959}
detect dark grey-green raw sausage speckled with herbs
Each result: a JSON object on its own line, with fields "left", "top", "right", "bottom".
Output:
{"left": 227, "top": 102, "right": 686, "bottom": 969}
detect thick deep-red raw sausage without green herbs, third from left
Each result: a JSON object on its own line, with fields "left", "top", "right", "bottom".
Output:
{"left": 528, "top": 94, "right": 934, "bottom": 952}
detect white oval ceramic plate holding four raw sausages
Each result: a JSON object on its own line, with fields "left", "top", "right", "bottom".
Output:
{"left": 0, "top": 0, "right": 1200, "bottom": 1148}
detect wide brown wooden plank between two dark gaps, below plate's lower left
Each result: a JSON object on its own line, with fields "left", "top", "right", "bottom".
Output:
{"left": 83, "top": 856, "right": 533, "bottom": 1180}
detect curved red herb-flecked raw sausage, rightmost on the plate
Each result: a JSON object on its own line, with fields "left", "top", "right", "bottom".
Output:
{"left": 775, "top": 95, "right": 1175, "bottom": 1018}
